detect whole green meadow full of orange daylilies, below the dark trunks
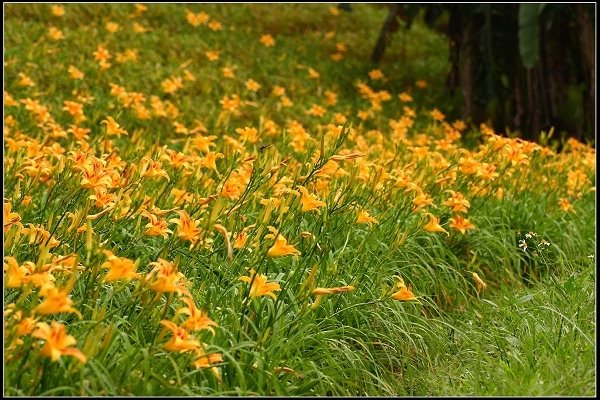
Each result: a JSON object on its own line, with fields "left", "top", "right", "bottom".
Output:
{"left": 3, "top": 4, "right": 596, "bottom": 396}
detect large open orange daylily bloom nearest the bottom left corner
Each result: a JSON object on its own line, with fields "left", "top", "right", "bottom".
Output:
{"left": 32, "top": 321, "right": 87, "bottom": 363}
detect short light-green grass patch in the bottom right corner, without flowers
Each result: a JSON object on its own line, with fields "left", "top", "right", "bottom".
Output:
{"left": 422, "top": 260, "right": 596, "bottom": 396}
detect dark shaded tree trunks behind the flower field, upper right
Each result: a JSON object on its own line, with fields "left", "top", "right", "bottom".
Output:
{"left": 370, "top": 3, "right": 596, "bottom": 144}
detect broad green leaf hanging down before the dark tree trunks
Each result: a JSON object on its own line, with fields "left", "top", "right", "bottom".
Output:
{"left": 519, "top": 3, "right": 545, "bottom": 68}
